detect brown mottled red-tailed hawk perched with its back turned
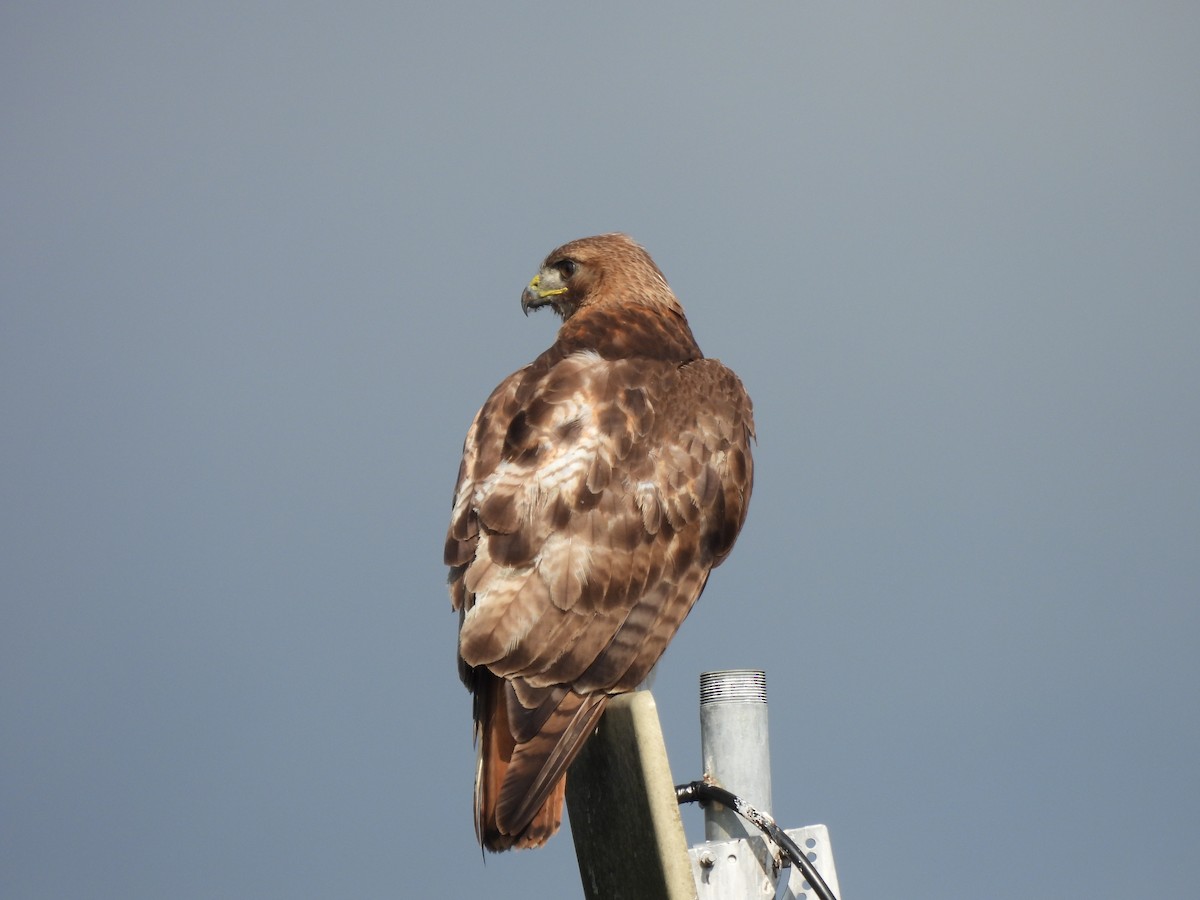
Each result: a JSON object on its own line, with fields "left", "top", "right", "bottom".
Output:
{"left": 445, "top": 234, "right": 754, "bottom": 851}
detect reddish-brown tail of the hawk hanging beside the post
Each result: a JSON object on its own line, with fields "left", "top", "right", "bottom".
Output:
{"left": 474, "top": 667, "right": 608, "bottom": 851}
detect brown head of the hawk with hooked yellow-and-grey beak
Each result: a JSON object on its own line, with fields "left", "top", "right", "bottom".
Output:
{"left": 521, "top": 234, "right": 679, "bottom": 319}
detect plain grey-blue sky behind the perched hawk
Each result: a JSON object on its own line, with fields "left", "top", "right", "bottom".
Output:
{"left": 0, "top": 0, "right": 1200, "bottom": 900}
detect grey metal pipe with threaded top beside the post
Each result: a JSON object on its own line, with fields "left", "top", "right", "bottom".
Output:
{"left": 700, "top": 668, "right": 770, "bottom": 841}
